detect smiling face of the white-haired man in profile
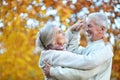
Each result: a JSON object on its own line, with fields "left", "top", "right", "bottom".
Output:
{"left": 85, "top": 20, "right": 101, "bottom": 41}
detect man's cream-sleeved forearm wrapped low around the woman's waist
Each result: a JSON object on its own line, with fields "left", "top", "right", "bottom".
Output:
{"left": 50, "top": 67, "right": 98, "bottom": 80}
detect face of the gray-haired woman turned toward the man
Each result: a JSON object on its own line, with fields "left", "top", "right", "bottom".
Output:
{"left": 54, "top": 27, "right": 67, "bottom": 46}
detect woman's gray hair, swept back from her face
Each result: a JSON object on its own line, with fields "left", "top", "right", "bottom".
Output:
{"left": 36, "top": 23, "right": 55, "bottom": 50}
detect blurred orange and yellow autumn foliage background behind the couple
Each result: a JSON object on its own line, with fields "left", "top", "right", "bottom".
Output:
{"left": 0, "top": 0, "right": 120, "bottom": 80}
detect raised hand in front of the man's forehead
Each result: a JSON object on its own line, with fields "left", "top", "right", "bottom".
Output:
{"left": 70, "top": 16, "right": 86, "bottom": 32}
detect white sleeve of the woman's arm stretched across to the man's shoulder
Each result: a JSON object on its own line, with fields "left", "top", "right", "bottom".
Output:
{"left": 47, "top": 43, "right": 113, "bottom": 69}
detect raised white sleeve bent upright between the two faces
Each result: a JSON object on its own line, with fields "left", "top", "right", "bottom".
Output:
{"left": 65, "top": 29, "right": 84, "bottom": 54}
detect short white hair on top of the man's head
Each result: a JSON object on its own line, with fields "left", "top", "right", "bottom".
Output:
{"left": 88, "top": 12, "right": 108, "bottom": 28}
